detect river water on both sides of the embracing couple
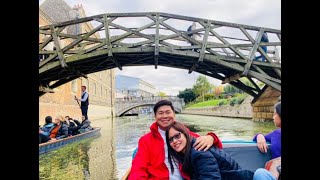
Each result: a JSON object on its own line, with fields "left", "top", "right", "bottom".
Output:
{"left": 39, "top": 114, "right": 275, "bottom": 180}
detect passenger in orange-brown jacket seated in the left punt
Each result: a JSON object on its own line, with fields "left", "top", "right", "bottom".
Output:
{"left": 49, "top": 115, "right": 68, "bottom": 142}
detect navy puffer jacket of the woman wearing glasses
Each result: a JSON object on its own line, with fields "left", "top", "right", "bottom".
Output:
{"left": 190, "top": 139, "right": 253, "bottom": 180}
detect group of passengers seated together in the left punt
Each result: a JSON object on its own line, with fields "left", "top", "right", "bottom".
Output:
{"left": 39, "top": 115, "right": 93, "bottom": 144}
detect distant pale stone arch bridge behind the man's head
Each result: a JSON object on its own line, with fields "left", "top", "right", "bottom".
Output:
{"left": 115, "top": 96, "right": 185, "bottom": 117}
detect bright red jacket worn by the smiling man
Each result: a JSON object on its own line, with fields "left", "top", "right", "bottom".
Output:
{"left": 129, "top": 122, "right": 222, "bottom": 180}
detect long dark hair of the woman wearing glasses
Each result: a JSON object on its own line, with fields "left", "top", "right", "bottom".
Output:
{"left": 166, "top": 121, "right": 193, "bottom": 174}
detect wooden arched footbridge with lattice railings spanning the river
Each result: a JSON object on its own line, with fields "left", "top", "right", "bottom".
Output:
{"left": 39, "top": 12, "right": 281, "bottom": 97}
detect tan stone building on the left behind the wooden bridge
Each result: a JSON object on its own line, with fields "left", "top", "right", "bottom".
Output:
{"left": 39, "top": 0, "right": 115, "bottom": 124}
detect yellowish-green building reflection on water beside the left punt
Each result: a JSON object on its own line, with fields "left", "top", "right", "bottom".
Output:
{"left": 39, "top": 116, "right": 117, "bottom": 180}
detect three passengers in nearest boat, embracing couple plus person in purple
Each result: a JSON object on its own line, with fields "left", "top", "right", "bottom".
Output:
{"left": 129, "top": 100, "right": 281, "bottom": 180}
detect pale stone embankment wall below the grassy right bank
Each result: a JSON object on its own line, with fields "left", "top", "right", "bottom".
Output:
{"left": 181, "top": 96, "right": 253, "bottom": 119}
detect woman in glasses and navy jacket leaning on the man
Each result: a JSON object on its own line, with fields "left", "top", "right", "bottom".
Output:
{"left": 166, "top": 121, "right": 253, "bottom": 180}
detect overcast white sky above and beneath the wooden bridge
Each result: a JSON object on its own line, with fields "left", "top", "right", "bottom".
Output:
{"left": 39, "top": 0, "right": 281, "bottom": 95}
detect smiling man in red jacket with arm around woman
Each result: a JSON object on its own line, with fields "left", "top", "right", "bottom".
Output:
{"left": 129, "top": 100, "right": 222, "bottom": 180}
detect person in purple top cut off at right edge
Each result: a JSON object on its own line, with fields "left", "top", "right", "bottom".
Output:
{"left": 253, "top": 102, "right": 281, "bottom": 180}
